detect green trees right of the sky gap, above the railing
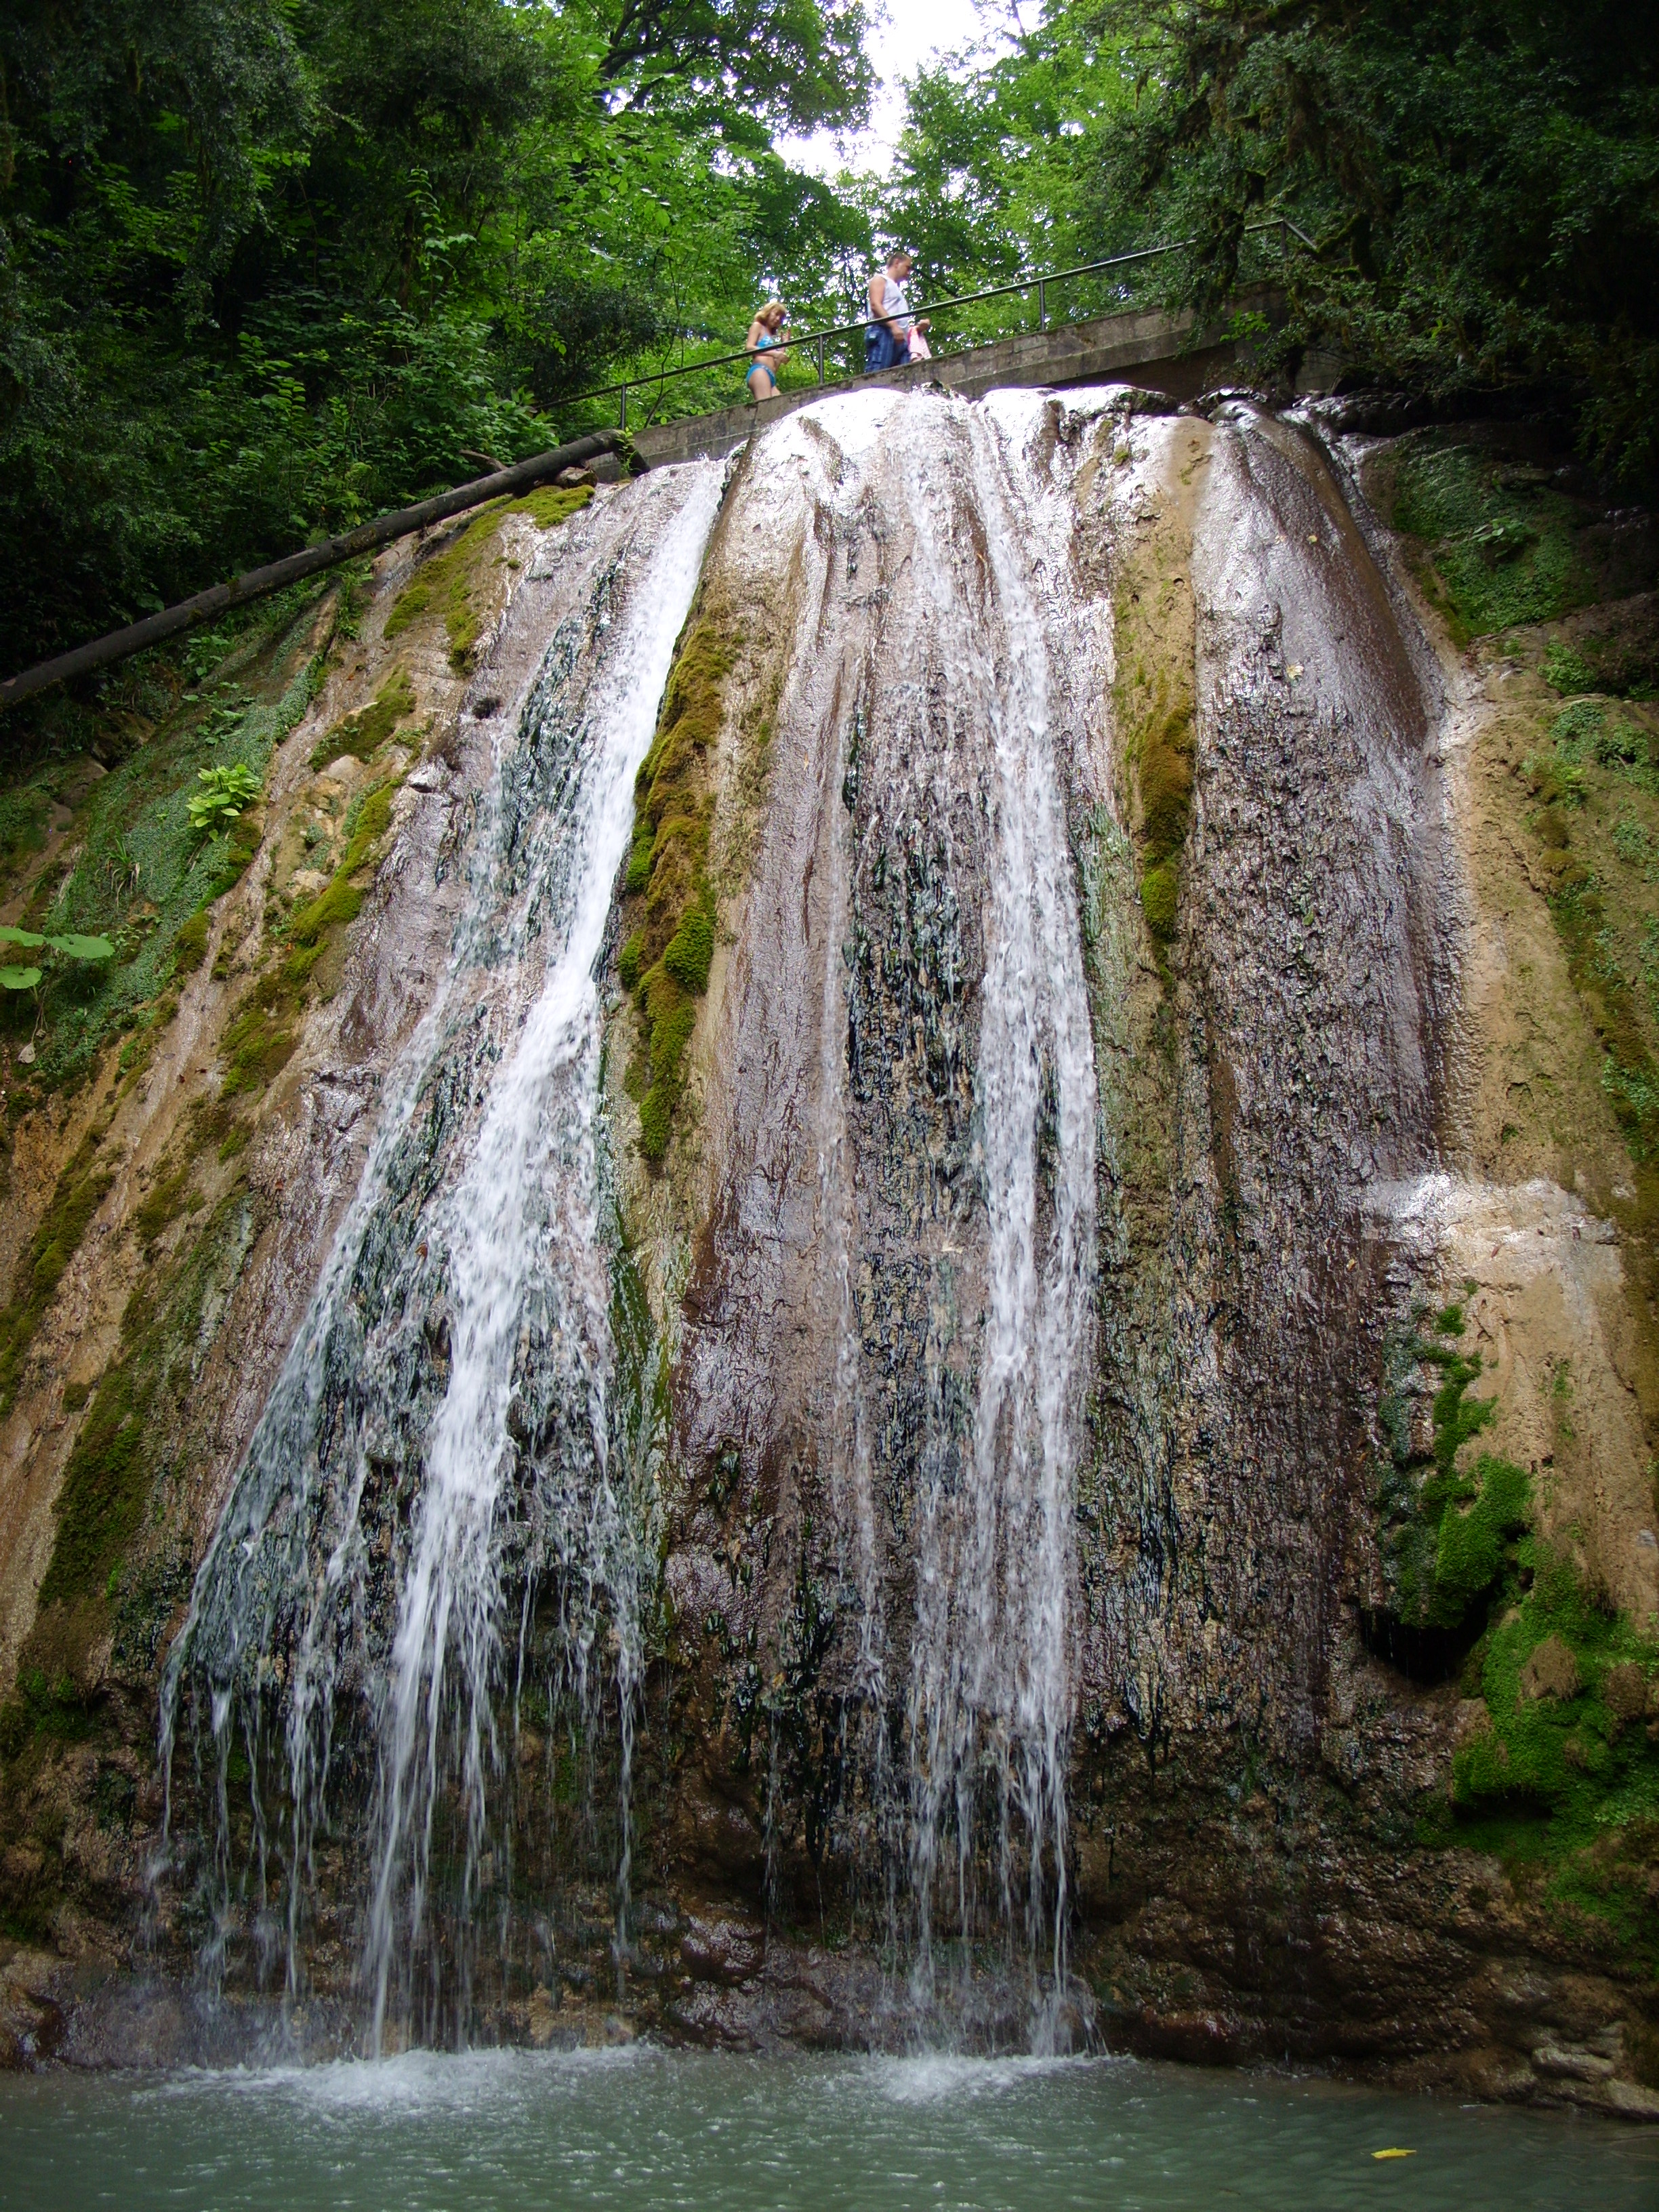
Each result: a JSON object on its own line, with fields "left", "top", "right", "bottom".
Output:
{"left": 880, "top": 0, "right": 1659, "bottom": 487}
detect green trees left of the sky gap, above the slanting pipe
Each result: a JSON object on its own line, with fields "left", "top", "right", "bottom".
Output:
{"left": 0, "top": 0, "right": 869, "bottom": 665}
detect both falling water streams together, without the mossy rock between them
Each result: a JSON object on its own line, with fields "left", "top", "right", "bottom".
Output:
{"left": 164, "top": 396, "right": 1119, "bottom": 2048}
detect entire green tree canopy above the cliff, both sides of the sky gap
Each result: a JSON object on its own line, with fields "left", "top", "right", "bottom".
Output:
{"left": 0, "top": 0, "right": 1659, "bottom": 690}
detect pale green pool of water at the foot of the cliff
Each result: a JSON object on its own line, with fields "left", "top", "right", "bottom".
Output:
{"left": 0, "top": 2046, "right": 1659, "bottom": 2212}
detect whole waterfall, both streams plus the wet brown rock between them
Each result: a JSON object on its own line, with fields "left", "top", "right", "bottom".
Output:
{"left": 164, "top": 394, "right": 1111, "bottom": 2048}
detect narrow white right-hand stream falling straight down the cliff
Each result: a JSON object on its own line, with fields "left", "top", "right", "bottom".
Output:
{"left": 909, "top": 405, "right": 1095, "bottom": 2039}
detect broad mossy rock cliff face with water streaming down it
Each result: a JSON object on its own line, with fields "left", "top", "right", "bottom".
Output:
{"left": 0, "top": 387, "right": 1659, "bottom": 2112}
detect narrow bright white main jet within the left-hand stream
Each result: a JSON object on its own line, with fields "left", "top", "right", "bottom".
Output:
{"left": 369, "top": 471, "right": 712, "bottom": 2046}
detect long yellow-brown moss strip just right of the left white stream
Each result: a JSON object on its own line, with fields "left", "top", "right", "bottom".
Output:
{"left": 617, "top": 600, "right": 741, "bottom": 1162}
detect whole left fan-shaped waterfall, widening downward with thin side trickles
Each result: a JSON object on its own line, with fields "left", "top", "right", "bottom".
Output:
{"left": 161, "top": 464, "right": 721, "bottom": 2046}
